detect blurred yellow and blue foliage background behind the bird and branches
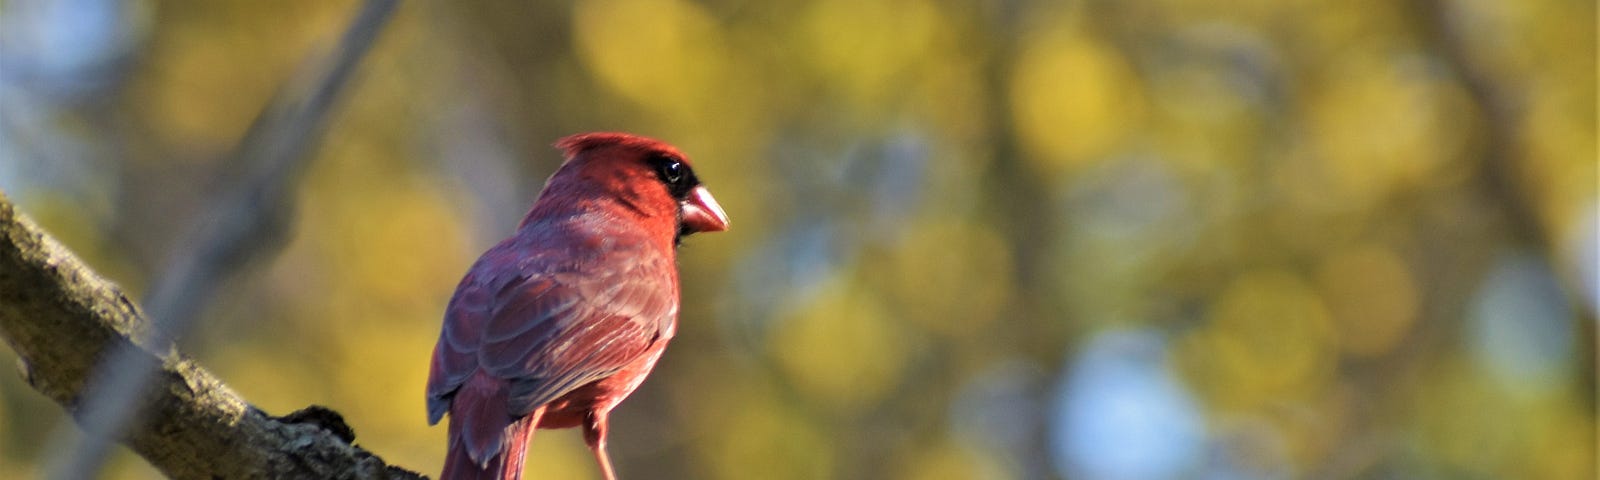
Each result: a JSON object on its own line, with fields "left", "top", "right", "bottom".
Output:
{"left": 0, "top": 0, "right": 1600, "bottom": 480}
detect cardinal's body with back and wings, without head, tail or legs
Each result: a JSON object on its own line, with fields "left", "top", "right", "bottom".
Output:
{"left": 427, "top": 216, "right": 678, "bottom": 461}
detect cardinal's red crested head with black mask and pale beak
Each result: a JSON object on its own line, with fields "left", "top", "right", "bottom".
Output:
{"left": 530, "top": 133, "right": 728, "bottom": 238}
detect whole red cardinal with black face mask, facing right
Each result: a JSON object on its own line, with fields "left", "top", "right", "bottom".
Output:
{"left": 427, "top": 133, "right": 728, "bottom": 480}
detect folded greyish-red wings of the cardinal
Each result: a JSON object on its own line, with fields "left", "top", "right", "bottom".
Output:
{"left": 429, "top": 236, "right": 677, "bottom": 422}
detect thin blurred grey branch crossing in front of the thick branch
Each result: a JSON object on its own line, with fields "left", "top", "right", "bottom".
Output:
{"left": 48, "top": 0, "right": 400, "bottom": 478}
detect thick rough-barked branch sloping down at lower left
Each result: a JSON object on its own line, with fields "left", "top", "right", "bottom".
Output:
{"left": 0, "top": 194, "right": 424, "bottom": 478}
